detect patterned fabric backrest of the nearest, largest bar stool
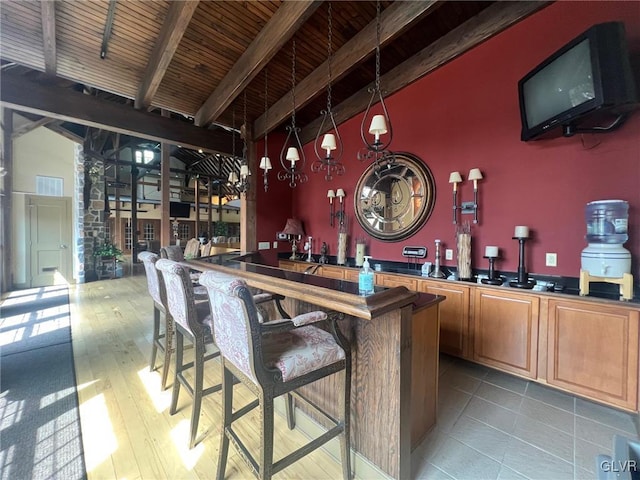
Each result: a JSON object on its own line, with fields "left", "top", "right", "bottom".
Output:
{"left": 200, "top": 271, "right": 262, "bottom": 382}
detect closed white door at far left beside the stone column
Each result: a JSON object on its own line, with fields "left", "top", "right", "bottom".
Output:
{"left": 27, "top": 195, "right": 72, "bottom": 287}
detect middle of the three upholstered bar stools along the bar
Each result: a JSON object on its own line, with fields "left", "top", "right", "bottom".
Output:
{"left": 156, "top": 259, "right": 221, "bottom": 448}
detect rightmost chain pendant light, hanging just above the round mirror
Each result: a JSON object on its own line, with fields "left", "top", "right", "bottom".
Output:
{"left": 358, "top": 0, "right": 395, "bottom": 167}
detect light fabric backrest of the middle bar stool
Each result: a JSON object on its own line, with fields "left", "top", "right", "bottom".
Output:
{"left": 156, "top": 258, "right": 201, "bottom": 335}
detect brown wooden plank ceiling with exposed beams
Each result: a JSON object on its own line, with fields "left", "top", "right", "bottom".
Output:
{"left": 0, "top": 0, "right": 546, "bottom": 191}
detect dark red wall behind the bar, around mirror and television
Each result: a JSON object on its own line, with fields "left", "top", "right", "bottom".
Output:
{"left": 258, "top": 2, "right": 640, "bottom": 280}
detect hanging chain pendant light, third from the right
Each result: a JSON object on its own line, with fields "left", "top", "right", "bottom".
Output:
{"left": 278, "top": 39, "right": 307, "bottom": 188}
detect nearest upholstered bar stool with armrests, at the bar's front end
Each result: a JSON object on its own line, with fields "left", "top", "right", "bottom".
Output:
{"left": 200, "top": 272, "right": 351, "bottom": 480}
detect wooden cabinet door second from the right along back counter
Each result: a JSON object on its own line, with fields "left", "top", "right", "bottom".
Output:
{"left": 473, "top": 288, "right": 540, "bottom": 378}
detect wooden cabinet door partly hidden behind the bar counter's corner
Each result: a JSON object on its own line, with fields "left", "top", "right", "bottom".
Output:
{"left": 418, "top": 280, "right": 470, "bottom": 357}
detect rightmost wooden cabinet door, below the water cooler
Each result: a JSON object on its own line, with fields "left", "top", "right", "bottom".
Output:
{"left": 547, "top": 300, "right": 639, "bottom": 410}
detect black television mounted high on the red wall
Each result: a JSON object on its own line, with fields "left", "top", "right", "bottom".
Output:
{"left": 518, "top": 22, "right": 638, "bottom": 141}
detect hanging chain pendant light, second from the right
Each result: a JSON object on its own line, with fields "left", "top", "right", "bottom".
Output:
{"left": 311, "top": 2, "right": 345, "bottom": 182}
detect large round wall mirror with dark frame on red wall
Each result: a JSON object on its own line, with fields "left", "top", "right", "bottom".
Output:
{"left": 354, "top": 153, "right": 435, "bottom": 241}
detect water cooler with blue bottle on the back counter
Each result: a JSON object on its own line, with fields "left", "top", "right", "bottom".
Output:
{"left": 580, "top": 200, "right": 633, "bottom": 300}
